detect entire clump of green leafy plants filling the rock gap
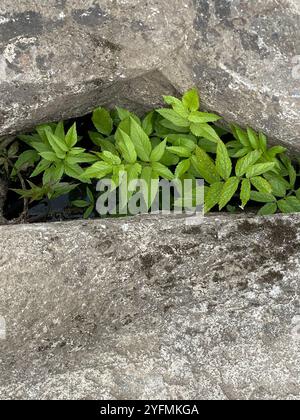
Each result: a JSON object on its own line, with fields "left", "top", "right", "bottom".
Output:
{"left": 0, "top": 89, "right": 300, "bottom": 218}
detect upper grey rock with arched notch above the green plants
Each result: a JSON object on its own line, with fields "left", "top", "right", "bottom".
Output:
{"left": 0, "top": 0, "right": 300, "bottom": 150}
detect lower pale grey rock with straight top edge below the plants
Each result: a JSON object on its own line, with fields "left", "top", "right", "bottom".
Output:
{"left": 0, "top": 216, "right": 300, "bottom": 400}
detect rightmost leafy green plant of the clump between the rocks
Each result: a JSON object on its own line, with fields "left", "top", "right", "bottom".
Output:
{"left": 203, "top": 126, "right": 300, "bottom": 215}
